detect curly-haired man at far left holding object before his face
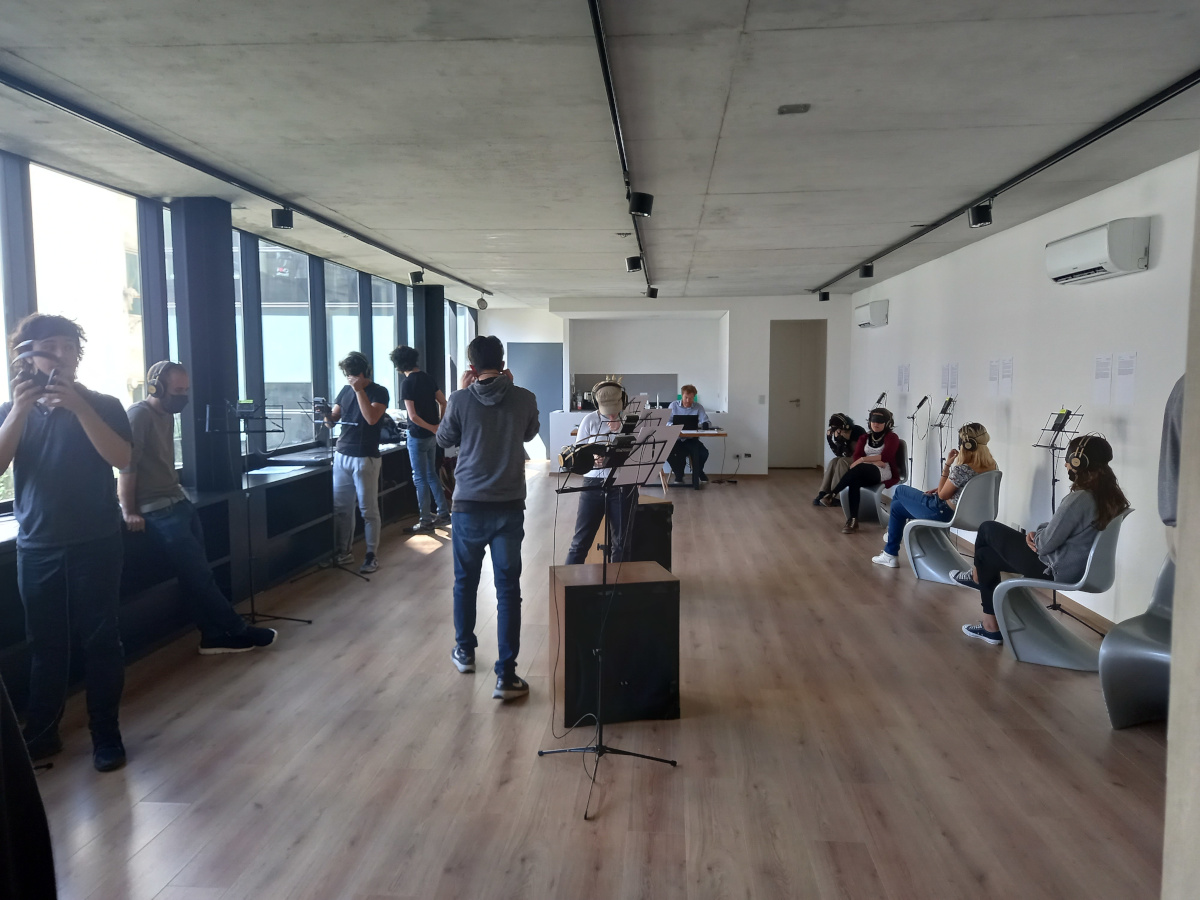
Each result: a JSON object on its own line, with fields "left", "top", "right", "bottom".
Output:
{"left": 0, "top": 313, "right": 132, "bottom": 772}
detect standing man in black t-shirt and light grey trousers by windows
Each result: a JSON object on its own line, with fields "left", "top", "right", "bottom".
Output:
{"left": 325, "top": 350, "right": 389, "bottom": 575}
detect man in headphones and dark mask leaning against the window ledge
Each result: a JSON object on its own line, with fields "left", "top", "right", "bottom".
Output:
{"left": 116, "top": 360, "right": 276, "bottom": 655}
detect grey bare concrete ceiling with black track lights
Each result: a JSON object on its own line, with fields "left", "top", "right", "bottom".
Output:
{"left": 0, "top": 0, "right": 1200, "bottom": 306}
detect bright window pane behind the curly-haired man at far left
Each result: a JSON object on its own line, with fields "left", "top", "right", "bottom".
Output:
{"left": 29, "top": 166, "right": 145, "bottom": 406}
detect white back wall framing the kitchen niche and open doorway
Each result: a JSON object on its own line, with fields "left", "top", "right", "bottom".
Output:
{"left": 550, "top": 294, "right": 851, "bottom": 475}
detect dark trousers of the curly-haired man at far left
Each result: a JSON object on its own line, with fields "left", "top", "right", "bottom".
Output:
{"left": 17, "top": 534, "right": 125, "bottom": 743}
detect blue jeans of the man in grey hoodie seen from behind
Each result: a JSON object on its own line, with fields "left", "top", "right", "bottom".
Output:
{"left": 450, "top": 509, "right": 524, "bottom": 674}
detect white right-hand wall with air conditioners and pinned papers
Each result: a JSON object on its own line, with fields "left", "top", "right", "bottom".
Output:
{"left": 850, "top": 154, "right": 1196, "bottom": 620}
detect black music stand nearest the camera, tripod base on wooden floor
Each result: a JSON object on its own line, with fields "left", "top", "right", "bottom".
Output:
{"left": 538, "top": 425, "right": 683, "bottom": 820}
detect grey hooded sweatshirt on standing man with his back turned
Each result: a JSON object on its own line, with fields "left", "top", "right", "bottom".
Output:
{"left": 437, "top": 376, "right": 539, "bottom": 512}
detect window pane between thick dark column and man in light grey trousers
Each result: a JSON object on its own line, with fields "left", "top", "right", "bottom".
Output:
{"left": 258, "top": 241, "right": 316, "bottom": 450}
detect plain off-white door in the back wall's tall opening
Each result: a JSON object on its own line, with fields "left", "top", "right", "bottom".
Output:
{"left": 767, "top": 319, "right": 827, "bottom": 469}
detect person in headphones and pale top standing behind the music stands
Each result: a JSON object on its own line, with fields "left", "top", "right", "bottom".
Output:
{"left": 566, "top": 382, "right": 637, "bottom": 565}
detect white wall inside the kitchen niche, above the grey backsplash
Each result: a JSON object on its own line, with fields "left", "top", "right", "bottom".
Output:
{"left": 570, "top": 317, "right": 728, "bottom": 410}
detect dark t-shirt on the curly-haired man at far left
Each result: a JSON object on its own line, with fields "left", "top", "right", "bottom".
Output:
{"left": 0, "top": 385, "right": 133, "bottom": 550}
